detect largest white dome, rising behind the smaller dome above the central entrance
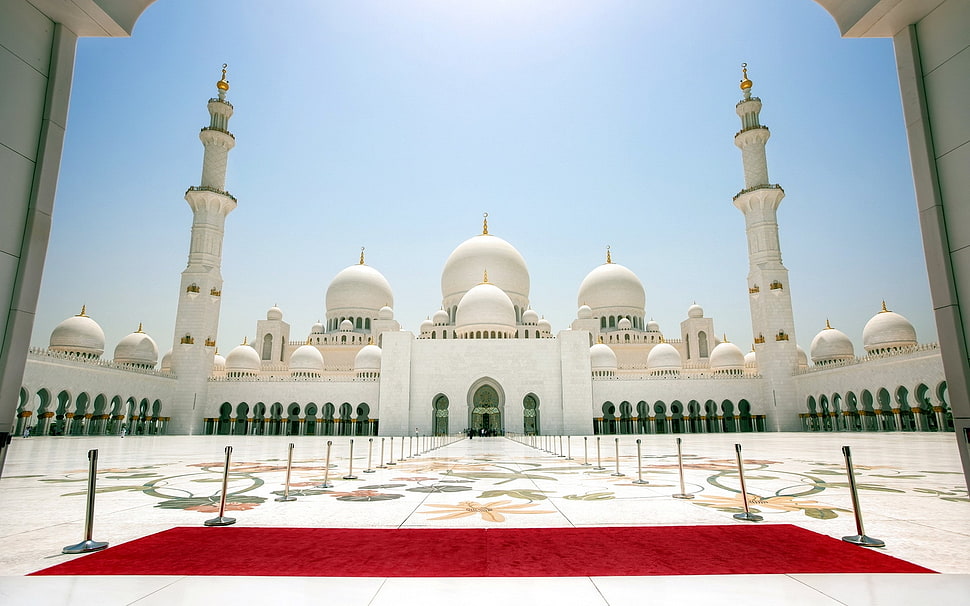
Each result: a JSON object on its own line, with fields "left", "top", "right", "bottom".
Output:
{"left": 441, "top": 227, "right": 529, "bottom": 310}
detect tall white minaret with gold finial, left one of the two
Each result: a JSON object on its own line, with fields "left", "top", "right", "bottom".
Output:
{"left": 169, "top": 64, "right": 236, "bottom": 434}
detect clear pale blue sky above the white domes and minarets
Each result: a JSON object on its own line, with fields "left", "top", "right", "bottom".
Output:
{"left": 32, "top": 0, "right": 936, "bottom": 358}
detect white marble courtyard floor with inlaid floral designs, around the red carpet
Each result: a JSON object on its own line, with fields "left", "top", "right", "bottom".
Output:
{"left": 0, "top": 434, "right": 970, "bottom": 606}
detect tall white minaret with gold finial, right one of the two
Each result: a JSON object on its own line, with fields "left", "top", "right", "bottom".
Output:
{"left": 734, "top": 63, "right": 799, "bottom": 431}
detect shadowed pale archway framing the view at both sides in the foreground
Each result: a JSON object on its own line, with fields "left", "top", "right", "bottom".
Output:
{"left": 0, "top": 0, "right": 970, "bottom": 494}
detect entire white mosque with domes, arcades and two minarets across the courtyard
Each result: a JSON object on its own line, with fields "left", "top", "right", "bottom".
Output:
{"left": 16, "top": 69, "right": 953, "bottom": 436}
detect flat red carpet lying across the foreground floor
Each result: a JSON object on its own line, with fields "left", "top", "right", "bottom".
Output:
{"left": 33, "top": 524, "right": 933, "bottom": 577}
